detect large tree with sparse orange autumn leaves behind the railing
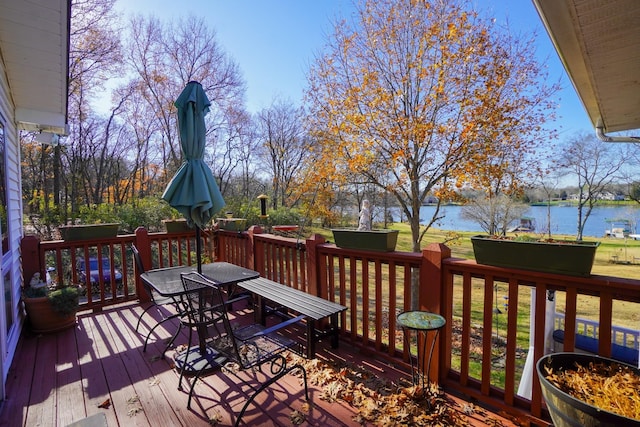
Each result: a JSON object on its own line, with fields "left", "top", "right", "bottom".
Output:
{"left": 301, "top": 0, "right": 558, "bottom": 251}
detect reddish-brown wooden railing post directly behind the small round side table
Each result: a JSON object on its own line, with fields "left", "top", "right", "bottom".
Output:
{"left": 418, "top": 243, "right": 451, "bottom": 382}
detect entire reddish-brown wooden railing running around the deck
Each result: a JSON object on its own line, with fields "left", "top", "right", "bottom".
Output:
{"left": 23, "top": 227, "right": 640, "bottom": 424}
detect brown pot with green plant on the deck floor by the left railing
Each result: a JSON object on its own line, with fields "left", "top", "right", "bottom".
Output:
{"left": 22, "top": 283, "right": 80, "bottom": 333}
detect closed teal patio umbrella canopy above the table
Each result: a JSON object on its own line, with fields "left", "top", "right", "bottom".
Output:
{"left": 162, "top": 82, "right": 225, "bottom": 228}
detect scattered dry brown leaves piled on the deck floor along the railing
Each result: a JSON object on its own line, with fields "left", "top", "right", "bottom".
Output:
{"left": 290, "top": 355, "right": 500, "bottom": 426}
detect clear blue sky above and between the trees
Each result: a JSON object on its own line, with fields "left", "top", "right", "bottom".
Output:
{"left": 116, "top": 0, "right": 593, "bottom": 139}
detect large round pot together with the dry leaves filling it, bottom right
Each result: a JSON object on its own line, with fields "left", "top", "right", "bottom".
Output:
{"left": 536, "top": 352, "right": 640, "bottom": 427}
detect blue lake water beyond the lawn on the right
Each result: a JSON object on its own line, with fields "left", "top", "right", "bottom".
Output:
{"left": 393, "top": 205, "right": 640, "bottom": 237}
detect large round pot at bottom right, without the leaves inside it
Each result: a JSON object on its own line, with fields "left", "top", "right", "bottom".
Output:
{"left": 536, "top": 353, "right": 640, "bottom": 427}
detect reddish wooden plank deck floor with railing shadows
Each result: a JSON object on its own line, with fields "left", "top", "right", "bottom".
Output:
{"left": 0, "top": 303, "right": 514, "bottom": 427}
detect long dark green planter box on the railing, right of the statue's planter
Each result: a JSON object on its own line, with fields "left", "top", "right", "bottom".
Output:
{"left": 471, "top": 236, "right": 600, "bottom": 276}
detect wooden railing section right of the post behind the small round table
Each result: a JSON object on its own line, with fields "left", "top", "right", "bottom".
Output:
{"left": 440, "top": 259, "right": 640, "bottom": 419}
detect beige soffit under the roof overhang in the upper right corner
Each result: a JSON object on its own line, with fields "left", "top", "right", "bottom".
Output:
{"left": 533, "top": 0, "right": 640, "bottom": 132}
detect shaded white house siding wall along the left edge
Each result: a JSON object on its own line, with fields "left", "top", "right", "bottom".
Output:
{"left": 0, "top": 52, "right": 29, "bottom": 401}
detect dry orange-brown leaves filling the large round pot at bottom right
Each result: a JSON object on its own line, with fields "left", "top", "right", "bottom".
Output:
{"left": 545, "top": 362, "right": 640, "bottom": 420}
